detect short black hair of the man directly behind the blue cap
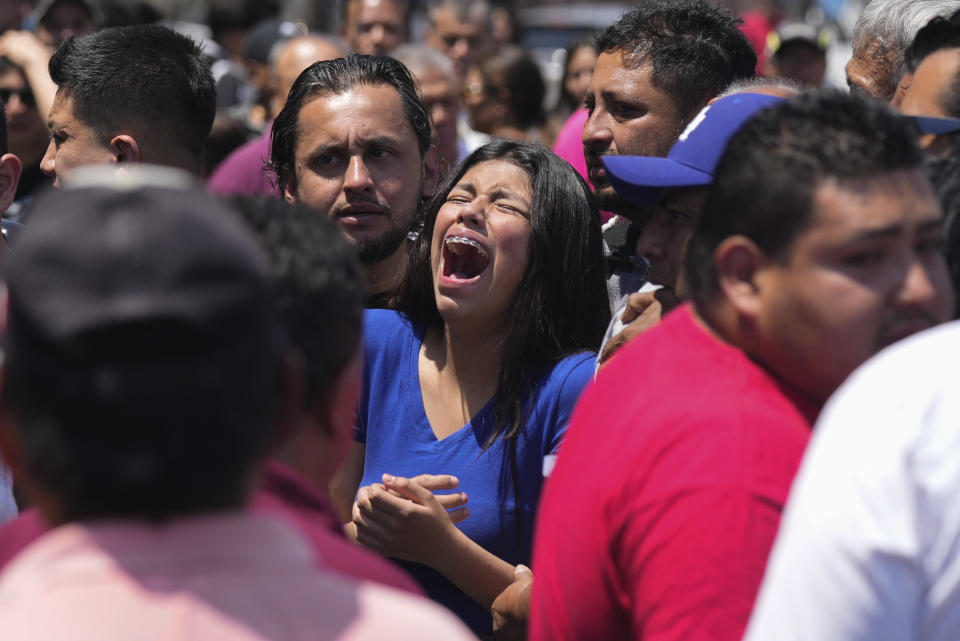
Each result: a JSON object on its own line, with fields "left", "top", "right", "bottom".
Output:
{"left": 597, "top": 0, "right": 757, "bottom": 117}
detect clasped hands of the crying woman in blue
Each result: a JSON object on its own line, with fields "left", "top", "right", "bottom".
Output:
{"left": 353, "top": 474, "right": 470, "bottom": 565}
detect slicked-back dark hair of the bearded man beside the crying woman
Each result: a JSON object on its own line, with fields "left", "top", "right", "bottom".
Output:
{"left": 268, "top": 54, "right": 430, "bottom": 190}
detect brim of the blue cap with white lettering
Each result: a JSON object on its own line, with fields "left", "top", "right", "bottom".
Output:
{"left": 602, "top": 156, "right": 713, "bottom": 205}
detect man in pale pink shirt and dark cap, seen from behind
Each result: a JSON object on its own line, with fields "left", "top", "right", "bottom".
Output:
{"left": 0, "top": 167, "right": 470, "bottom": 641}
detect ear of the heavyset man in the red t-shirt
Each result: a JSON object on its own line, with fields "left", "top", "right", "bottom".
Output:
{"left": 713, "top": 236, "right": 770, "bottom": 318}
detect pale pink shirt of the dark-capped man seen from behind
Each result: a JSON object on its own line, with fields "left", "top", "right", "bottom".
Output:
{"left": 0, "top": 513, "right": 472, "bottom": 641}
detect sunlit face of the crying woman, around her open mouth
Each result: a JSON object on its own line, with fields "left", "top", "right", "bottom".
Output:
{"left": 430, "top": 160, "right": 533, "bottom": 329}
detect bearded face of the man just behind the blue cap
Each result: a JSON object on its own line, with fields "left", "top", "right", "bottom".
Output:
{"left": 583, "top": 51, "right": 683, "bottom": 211}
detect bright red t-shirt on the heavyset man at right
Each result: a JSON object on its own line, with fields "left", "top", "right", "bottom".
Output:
{"left": 530, "top": 306, "right": 819, "bottom": 641}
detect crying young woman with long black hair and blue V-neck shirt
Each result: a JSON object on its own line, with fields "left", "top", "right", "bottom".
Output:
{"left": 334, "top": 140, "right": 610, "bottom": 635}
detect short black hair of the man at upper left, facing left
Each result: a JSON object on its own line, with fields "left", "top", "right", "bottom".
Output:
{"left": 49, "top": 25, "right": 216, "bottom": 158}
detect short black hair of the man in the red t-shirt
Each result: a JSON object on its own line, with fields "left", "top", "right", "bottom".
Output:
{"left": 685, "top": 90, "right": 923, "bottom": 303}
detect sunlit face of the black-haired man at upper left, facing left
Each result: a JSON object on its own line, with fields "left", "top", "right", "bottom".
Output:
{"left": 40, "top": 90, "right": 118, "bottom": 187}
